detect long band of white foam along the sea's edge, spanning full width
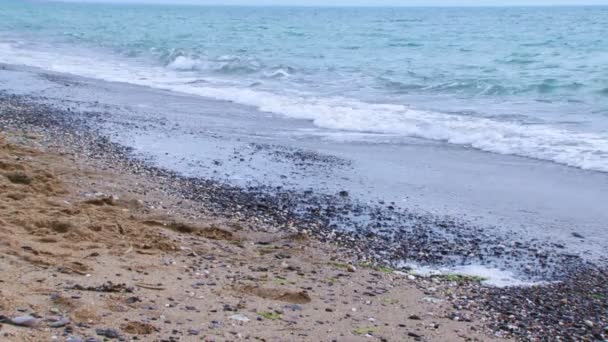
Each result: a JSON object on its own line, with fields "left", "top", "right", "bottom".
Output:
{"left": 0, "top": 42, "right": 608, "bottom": 172}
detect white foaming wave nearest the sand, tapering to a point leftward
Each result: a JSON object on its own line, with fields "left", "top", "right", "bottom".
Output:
{"left": 174, "top": 87, "right": 608, "bottom": 172}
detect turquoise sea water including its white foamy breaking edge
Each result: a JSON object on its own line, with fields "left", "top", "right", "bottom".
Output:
{"left": 0, "top": 0, "right": 608, "bottom": 172}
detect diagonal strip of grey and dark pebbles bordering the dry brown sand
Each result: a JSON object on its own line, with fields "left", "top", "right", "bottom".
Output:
{"left": 0, "top": 90, "right": 608, "bottom": 340}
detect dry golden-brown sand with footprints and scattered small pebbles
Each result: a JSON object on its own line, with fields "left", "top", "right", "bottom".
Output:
{"left": 0, "top": 132, "right": 492, "bottom": 341}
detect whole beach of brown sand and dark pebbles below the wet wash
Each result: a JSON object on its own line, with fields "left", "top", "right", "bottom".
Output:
{"left": 0, "top": 66, "right": 607, "bottom": 341}
